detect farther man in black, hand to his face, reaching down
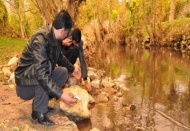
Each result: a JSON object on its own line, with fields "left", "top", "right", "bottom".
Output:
{"left": 61, "top": 28, "right": 92, "bottom": 91}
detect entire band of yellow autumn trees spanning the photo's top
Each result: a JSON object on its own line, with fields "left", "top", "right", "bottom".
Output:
{"left": 0, "top": 0, "right": 189, "bottom": 38}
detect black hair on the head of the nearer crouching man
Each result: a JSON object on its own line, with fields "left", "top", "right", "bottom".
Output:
{"left": 52, "top": 10, "right": 73, "bottom": 29}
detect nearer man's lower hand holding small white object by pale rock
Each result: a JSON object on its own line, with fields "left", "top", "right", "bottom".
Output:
{"left": 60, "top": 92, "right": 77, "bottom": 106}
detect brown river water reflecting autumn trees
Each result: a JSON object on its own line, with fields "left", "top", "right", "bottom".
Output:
{"left": 78, "top": 45, "right": 190, "bottom": 131}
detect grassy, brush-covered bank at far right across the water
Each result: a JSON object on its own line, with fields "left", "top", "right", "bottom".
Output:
{"left": 141, "top": 18, "right": 190, "bottom": 53}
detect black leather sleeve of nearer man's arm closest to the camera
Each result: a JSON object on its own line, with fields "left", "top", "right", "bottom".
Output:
{"left": 33, "top": 36, "right": 62, "bottom": 99}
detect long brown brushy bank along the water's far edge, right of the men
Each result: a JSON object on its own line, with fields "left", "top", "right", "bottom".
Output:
{"left": 83, "top": 18, "right": 190, "bottom": 63}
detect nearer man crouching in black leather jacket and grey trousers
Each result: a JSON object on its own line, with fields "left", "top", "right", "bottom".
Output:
{"left": 15, "top": 10, "right": 81, "bottom": 125}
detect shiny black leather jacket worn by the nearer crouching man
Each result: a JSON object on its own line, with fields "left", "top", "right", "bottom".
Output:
{"left": 15, "top": 25, "right": 74, "bottom": 99}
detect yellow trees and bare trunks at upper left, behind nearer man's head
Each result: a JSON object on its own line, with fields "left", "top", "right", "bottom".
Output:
{"left": 0, "top": 0, "right": 83, "bottom": 38}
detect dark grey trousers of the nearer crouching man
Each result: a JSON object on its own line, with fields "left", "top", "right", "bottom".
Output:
{"left": 16, "top": 67, "right": 69, "bottom": 113}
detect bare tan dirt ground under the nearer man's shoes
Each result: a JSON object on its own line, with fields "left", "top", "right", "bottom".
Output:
{"left": 0, "top": 83, "right": 78, "bottom": 131}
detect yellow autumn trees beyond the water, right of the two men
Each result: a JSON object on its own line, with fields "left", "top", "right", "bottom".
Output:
{"left": 76, "top": 0, "right": 190, "bottom": 45}
